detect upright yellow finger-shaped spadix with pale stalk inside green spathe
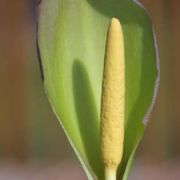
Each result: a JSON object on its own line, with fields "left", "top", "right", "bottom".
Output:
{"left": 101, "top": 18, "right": 125, "bottom": 180}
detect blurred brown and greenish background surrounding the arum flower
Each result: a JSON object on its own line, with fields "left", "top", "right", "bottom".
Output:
{"left": 0, "top": 0, "right": 180, "bottom": 180}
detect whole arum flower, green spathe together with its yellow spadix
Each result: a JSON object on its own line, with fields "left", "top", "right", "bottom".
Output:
{"left": 38, "top": 0, "right": 158, "bottom": 180}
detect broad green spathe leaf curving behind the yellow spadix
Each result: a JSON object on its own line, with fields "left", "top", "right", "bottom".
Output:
{"left": 38, "top": 0, "right": 157, "bottom": 180}
